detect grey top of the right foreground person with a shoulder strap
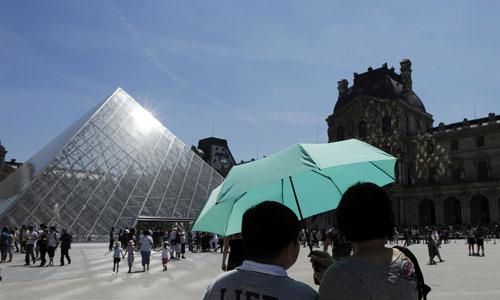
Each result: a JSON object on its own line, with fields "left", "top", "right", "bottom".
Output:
{"left": 319, "top": 253, "right": 418, "bottom": 300}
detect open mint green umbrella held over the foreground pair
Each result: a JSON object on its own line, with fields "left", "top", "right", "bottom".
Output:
{"left": 193, "top": 139, "right": 396, "bottom": 240}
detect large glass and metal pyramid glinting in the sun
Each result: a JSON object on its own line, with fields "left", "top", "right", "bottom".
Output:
{"left": 0, "top": 88, "right": 223, "bottom": 240}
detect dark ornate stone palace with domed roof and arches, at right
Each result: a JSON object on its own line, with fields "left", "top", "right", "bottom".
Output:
{"left": 326, "top": 59, "right": 500, "bottom": 226}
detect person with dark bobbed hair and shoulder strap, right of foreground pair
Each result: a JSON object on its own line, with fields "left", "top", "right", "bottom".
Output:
{"left": 311, "top": 183, "right": 420, "bottom": 300}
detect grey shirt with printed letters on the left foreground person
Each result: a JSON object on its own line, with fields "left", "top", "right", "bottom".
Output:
{"left": 203, "top": 260, "right": 318, "bottom": 300}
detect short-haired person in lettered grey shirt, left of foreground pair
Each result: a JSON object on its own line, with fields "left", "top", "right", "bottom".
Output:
{"left": 203, "top": 201, "right": 318, "bottom": 300}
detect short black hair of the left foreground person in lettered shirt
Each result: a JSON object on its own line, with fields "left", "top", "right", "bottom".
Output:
{"left": 241, "top": 201, "right": 300, "bottom": 262}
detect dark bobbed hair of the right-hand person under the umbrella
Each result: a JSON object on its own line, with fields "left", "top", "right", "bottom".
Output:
{"left": 337, "top": 182, "right": 394, "bottom": 242}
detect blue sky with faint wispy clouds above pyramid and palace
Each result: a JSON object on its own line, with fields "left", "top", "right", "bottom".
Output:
{"left": 0, "top": 0, "right": 500, "bottom": 161}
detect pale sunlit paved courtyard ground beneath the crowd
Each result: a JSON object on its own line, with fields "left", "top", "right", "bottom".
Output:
{"left": 0, "top": 240, "right": 500, "bottom": 300}
